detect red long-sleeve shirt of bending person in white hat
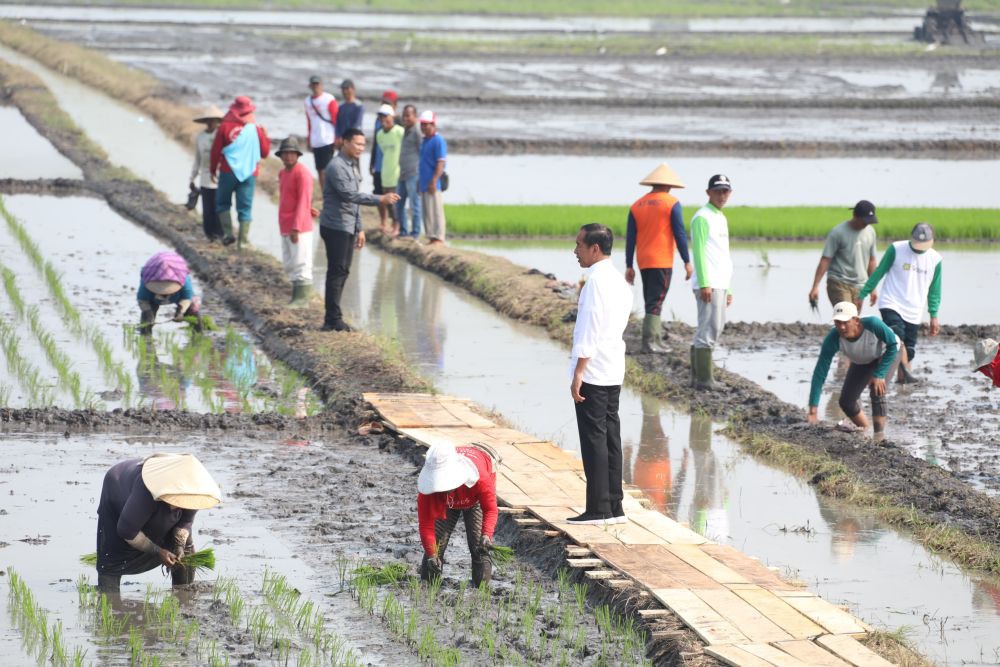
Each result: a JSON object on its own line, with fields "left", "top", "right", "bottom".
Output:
{"left": 417, "top": 447, "right": 498, "bottom": 558}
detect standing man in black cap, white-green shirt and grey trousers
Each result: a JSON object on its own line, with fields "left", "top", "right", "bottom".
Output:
{"left": 691, "top": 174, "right": 733, "bottom": 390}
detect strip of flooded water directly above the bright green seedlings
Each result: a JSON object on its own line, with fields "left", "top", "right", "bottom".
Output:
{"left": 445, "top": 155, "right": 1000, "bottom": 208}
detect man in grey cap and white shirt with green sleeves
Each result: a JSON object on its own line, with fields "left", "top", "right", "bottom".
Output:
{"left": 858, "top": 222, "right": 941, "bottom": 383}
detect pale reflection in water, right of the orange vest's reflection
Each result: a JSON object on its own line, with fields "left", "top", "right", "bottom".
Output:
{"left": 688, "top": 414, "right": 729, "bottom": 541}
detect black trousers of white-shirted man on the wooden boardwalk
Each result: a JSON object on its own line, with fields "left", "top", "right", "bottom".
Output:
{"left": 576, "top": 382, "right": 624, "bottom": 515}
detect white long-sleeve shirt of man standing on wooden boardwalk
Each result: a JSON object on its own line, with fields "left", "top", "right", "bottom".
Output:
{"left": 570, "top": 259, "right": 632, "bottom": 387}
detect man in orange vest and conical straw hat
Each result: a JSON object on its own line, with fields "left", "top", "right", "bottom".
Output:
{"left": 625, "top": 163, "right": 692, "bottom": 354}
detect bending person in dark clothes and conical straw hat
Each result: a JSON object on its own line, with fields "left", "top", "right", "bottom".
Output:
{"left": 97, "top": 454, "right": 222, "bottom": 593}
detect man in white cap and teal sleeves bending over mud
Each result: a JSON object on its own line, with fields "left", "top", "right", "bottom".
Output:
{"left": 808, "top": 301, "right": 899, "bottom": 438}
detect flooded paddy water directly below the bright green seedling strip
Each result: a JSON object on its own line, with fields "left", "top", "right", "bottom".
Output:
{"left": 454, "top": 240, "right": 1000, "bottom": 325}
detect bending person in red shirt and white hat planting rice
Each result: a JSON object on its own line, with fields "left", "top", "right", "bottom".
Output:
{"left": 417, "top": 444, "right": 497, "bottom": 586}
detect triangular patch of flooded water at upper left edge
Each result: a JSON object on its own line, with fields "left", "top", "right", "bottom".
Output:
{"left": 0, "top": 106, "right": 82, "bottom": 179}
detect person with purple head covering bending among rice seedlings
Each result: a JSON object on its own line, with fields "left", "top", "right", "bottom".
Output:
{"left": 136, "top": 251, "right": 201, "bottom": 334}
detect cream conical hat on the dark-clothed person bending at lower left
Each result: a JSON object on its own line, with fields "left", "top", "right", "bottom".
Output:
{"left": 142, "top": 454, "right": 222, "bottom": 510}
